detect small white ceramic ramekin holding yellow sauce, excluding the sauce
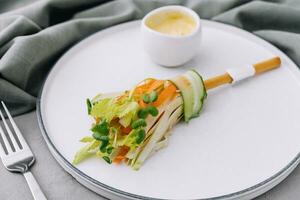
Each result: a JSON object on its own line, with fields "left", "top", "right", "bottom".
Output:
{"left": 141, "top": 6, "right": 202, "bottom": 67}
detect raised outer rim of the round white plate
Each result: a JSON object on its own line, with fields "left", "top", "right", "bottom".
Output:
{"left": 36, "top": 19, "right": 300, "bottom": 200}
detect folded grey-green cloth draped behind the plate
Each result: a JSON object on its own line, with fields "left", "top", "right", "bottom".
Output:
{"left": 0, "top": 0, "right": 300, "bottom": 115}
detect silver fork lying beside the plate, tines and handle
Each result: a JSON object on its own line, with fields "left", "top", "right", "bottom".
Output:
{"left": 0, "top": 101, "right": 46, "bottom": 200}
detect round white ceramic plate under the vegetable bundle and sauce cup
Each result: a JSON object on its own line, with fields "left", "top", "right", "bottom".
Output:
{"left": 38, "top": 20, "right": 300, "bottom": 199}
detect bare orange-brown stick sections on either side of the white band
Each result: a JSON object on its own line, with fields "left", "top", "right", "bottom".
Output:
{"left": 204, "top": 57, "right": 281, "bottom": 90}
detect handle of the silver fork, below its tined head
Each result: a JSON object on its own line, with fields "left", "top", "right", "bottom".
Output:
{"left": 23, "top": 171, "right": 47, "bottom": 200}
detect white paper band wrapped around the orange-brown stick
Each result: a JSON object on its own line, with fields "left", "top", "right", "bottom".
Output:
{"left": 226, "top": 65, "right": 255, "bottom": 83}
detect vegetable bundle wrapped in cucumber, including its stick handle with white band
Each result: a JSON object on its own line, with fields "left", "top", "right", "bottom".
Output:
{"left": 73, "top": 57, "right": 280, "bottom": 170}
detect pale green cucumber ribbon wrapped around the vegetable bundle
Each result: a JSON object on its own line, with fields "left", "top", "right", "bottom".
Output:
{"left": 171, "top": 70, "right": 207, "bottom": 122}
